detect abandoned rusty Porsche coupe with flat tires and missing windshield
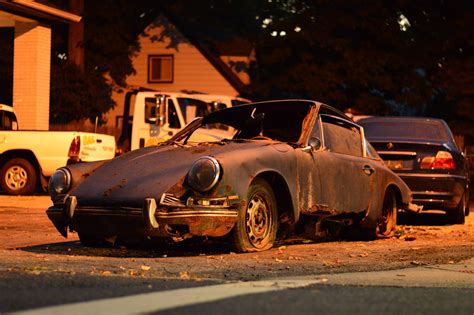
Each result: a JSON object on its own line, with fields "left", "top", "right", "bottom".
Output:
{"left": 47, "top": 100, "right": 411, "bottom": 252}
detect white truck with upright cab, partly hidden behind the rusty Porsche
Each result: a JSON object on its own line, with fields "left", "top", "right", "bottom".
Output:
{"left": 117, "top": 90, "right": 250, "bottom": 152}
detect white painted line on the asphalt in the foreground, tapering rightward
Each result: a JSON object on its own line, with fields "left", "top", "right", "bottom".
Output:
{"left": 15, "top": 277, "right": 326, "bottom": 315}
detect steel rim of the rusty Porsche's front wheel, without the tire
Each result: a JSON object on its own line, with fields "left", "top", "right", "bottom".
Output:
{"left": 245, "top": 193, "right": 273, "bottom": 248}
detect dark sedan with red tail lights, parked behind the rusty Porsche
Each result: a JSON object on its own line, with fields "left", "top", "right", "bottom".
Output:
{"left": 359, "top": 117, "right": 469, "bottom": 224}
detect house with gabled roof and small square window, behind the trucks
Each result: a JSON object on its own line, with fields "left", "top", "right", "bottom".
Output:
{"left": 105, "top": 15, "right": 253, "bottom": 128}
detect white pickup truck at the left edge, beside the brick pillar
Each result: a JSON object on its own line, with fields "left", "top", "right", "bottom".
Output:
{"left": 0, "top": 104, "right": 115, "bottom": 195}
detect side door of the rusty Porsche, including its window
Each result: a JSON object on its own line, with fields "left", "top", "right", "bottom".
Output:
{"left": 317, "top": 114, "right": 375, "bottom": 213}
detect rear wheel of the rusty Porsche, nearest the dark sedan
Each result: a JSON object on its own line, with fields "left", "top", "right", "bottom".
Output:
{"left": 375, "top": 189, "right": 398, "bottom": 238}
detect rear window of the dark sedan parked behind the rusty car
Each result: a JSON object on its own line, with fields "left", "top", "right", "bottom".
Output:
{"left": 359, "top": 120, "right": 449, "bottom": 142}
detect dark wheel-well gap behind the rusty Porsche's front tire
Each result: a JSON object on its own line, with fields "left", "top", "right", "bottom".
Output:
{"left": 255, "top": 172, "right": 295, "bottom": 233}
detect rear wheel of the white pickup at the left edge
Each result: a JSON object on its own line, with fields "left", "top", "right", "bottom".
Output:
{"left": 0, "top": 158, "right": 38, "bottom": 195}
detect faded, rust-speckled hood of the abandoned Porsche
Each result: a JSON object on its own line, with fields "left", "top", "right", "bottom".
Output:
{"left": 71, "top": 140, "right": 290, "bottom": 207}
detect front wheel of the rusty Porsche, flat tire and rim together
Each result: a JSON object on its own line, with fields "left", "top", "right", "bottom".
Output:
{"left": 232, "top": 178, "right": 278, "bottom": 252}
